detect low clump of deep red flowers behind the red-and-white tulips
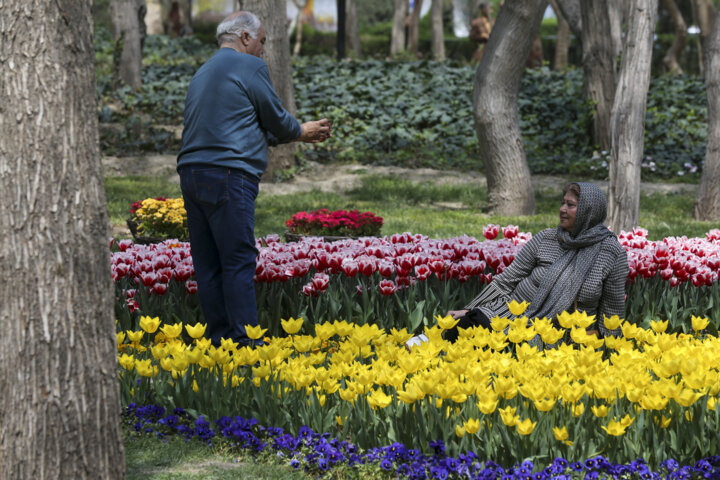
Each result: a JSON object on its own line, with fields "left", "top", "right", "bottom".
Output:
{"left": 285, "top": 208, "right": 383, "bottom": 237}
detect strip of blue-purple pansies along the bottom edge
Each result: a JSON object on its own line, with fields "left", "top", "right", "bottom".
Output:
{"left": 123, "top": 404, "right": 720, "bottom": 480}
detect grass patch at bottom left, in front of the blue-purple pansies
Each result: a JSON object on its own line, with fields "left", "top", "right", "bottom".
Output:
{"left": 125, "top": 431, "right": 310, "bottom": 480}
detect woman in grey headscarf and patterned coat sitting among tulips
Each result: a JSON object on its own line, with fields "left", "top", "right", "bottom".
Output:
{"left": 438, "top": 183, "right": 628, "bottom": 342}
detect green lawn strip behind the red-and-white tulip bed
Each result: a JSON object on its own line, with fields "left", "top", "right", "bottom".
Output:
{"left": 105, "top": 173, "right": 717, "bottom": 240}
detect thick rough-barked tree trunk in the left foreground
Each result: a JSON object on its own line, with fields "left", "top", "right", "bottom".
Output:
{"left": 0, "top": 0, "right": 125, "bottom": 480}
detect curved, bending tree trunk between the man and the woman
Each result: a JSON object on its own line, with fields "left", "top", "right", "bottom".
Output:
{"left": 473, "top": 0, "right": 547, "bottom": 215}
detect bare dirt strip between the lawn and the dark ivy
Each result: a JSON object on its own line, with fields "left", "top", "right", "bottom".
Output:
{"left": 102, "top": 155, "right": 697, "bottom": 195}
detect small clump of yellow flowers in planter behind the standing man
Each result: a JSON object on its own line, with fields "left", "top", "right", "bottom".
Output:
{"left": 135, "top": 198, "right": 188, "bottom": 239}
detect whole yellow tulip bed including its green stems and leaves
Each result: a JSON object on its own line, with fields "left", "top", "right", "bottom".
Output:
{"left": 118, "top": 314, "right": 720, "bottom": 468}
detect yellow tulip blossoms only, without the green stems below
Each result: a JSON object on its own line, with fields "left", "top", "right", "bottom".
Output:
{"left": 118, "top": 312, "right": 720, "bottom": 445}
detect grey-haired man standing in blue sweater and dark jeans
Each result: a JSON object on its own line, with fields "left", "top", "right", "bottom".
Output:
{"left": 177, "top": 12, "right": 331, "bottom": 345}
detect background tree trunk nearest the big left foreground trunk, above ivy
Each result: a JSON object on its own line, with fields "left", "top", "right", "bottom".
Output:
{"left": 110, "top": 0, "right": 142, "bottom": 88}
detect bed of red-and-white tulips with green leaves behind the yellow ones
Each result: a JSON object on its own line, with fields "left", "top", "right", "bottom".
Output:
{"left": 112, "top": 225, "right": 720, "bottom": 335}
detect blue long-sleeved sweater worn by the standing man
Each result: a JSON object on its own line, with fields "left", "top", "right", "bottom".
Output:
{"left": 178, "top": 48, "right": 301, "bottom": 178}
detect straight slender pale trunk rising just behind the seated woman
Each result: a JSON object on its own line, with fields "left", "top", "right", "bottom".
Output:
{"left": 608, "top": 0, "right": 658, "bottom": 233}
